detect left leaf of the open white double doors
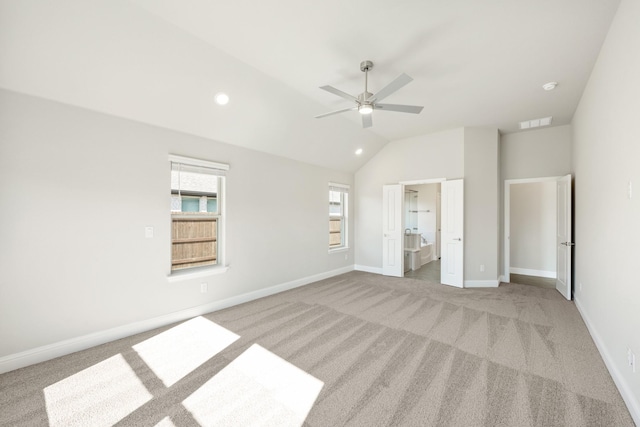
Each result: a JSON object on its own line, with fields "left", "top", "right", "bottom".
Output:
{"left": 382, "top": 184, "right": 404, "bottom": 277}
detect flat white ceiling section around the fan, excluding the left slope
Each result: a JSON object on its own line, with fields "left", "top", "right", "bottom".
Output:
{"left": 134, "top": 0, "right": 619, "bottom": 137}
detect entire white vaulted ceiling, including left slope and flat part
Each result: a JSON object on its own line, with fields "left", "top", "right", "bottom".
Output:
{"left": 0, "top": 0, "right": 619, "bottom": 171}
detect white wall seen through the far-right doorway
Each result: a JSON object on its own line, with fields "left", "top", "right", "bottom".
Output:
{"left": 509, "top": 181, "right": 557, "bottom": 277}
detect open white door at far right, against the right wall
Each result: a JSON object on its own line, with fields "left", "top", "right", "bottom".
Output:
{"left": 556, "top": 175, "right": 574, "bottom": 300}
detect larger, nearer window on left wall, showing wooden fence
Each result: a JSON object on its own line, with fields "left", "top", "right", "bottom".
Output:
{"left": 169, "top": 156, "right": 229, "bottom": 272}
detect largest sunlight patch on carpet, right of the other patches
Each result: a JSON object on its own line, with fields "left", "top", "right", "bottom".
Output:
{"left": 183, "top": 344, "right": 324, "bottom": 427}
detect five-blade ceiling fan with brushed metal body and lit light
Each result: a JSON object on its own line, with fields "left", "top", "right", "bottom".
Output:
{"left": 316, "top": 61, "right": 424, "bottom": 128}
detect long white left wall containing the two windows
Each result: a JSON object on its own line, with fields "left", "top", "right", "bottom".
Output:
{"left": 0, "top": 91, "right": 354, "bottom": 359}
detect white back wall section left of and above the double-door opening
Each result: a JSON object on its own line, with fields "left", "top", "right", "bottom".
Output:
{"left": 355, "top": 128, "right": 464, "bottom": 271}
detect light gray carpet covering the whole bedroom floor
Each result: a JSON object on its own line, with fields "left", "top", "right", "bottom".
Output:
{"left": 0, "top": 272, "right": 634, "bottom": 427}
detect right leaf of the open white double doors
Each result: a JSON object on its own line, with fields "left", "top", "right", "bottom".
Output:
{"left": 440, "top": 179, "right": 464, "bottom": 288}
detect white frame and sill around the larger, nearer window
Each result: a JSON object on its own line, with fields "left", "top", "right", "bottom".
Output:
{"left": 168, "top": 154, "right": 229, "bottom": 282}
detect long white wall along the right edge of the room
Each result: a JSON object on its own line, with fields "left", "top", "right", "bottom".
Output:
{"left": 573, "top": 0, "right": 640, "bottom": 425}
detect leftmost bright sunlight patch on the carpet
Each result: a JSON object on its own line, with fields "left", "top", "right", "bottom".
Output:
{"left": 44, "top": 354, "right": 153, "bottom": 427}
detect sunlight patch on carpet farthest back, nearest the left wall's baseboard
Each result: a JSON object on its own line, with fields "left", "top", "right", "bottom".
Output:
{"left": 133, "top": 317, "right": 240, "bottom": 387}
